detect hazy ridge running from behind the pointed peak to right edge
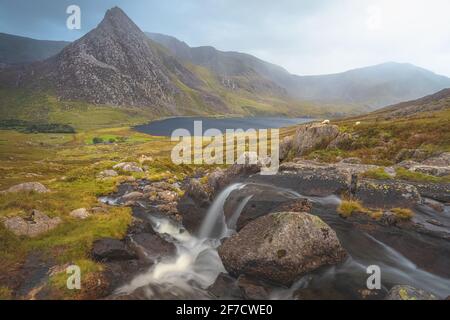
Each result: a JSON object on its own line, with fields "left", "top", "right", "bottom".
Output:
{"left": 147, "top": 33, "right": 450, "bottom": 111}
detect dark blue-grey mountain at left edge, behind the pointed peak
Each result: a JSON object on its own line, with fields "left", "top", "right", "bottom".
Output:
{"left": 0, "top": 33, "right": 70, "bottom": 64}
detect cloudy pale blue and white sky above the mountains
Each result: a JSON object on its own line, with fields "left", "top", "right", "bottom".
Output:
{"left": 0, "top": 0, "right": 450, "bottom": 76}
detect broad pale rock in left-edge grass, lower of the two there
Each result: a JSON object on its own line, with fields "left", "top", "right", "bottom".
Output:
{"left": 3, "top": 210, "right": 62, "bottom": 238}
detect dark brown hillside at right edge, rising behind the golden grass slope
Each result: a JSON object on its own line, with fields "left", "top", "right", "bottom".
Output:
{"left": 373, "top": 89, "right": 450, "bottom": 118}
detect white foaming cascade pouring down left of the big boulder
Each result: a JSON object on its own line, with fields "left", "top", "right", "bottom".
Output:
{"left": 117, "top": 184, "right": 248, "bottom": 299}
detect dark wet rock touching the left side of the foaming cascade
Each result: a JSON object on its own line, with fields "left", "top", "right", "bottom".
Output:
{"left": 127, "top": 232, "right": 176, "bottom": 261}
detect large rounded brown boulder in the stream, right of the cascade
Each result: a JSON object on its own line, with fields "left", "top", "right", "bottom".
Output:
{"left": 219, "top": 212, "right": 347, "bottom": 286}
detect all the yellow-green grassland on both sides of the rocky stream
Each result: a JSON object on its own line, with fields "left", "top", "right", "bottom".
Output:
{"left": 0, "top": 105, "right": 450, "bottom": 299}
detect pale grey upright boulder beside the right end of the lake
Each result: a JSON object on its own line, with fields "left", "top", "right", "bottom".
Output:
{"left": 292, "top": 123, "right": 339, "bottom": 156}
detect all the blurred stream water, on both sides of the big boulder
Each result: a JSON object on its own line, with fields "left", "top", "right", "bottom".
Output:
{"left": 107, "top": 183, "right": 450, "bottom": 299}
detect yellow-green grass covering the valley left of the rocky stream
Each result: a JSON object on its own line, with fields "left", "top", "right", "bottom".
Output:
{"left": 0, "top": 124, "right": 204, "bottom": 298}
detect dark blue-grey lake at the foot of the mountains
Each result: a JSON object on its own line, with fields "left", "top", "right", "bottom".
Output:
{"left": 134, "top": 117, "right": 313, "bottom": 136}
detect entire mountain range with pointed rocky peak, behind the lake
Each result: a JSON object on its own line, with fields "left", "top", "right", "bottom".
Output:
{"left": 0, "top": 8, "right": 450, "bottom": 116}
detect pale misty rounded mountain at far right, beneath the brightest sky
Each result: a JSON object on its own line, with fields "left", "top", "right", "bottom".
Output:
{"left": 290, "top": 62, "right": 450, "bottom": 109}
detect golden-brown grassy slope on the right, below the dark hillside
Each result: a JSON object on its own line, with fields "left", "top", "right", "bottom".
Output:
{"left": 280, "top": 108, "right": 450, "bottom": 166}
